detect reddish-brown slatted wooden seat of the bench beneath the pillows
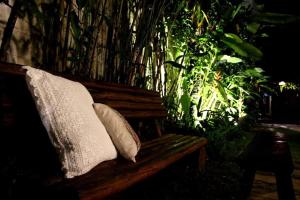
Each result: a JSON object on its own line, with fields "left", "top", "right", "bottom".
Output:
{"left": 56, "top": 134, "right": 206, "bottom": 200}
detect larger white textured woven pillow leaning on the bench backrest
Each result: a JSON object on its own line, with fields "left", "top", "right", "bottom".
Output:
{"left": 23, "top": 66, "right": 117, "bottom": 178}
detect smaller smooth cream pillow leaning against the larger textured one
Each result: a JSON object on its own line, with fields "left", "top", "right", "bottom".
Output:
{"left": 93, "top": 103, "right": 141, "bottom": 162}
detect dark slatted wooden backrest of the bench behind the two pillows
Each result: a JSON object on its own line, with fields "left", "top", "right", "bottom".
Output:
{"left": 0, "top": 62, "right": 167, "bottom": 181}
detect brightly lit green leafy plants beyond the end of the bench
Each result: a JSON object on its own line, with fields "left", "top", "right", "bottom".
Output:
{"left": 166, "top": 1, "right": 267, "bottom": 133}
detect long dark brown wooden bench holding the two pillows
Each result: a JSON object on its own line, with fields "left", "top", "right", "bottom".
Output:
{"left": 0, "top": 63, "right": 207, "bottom": 200}
